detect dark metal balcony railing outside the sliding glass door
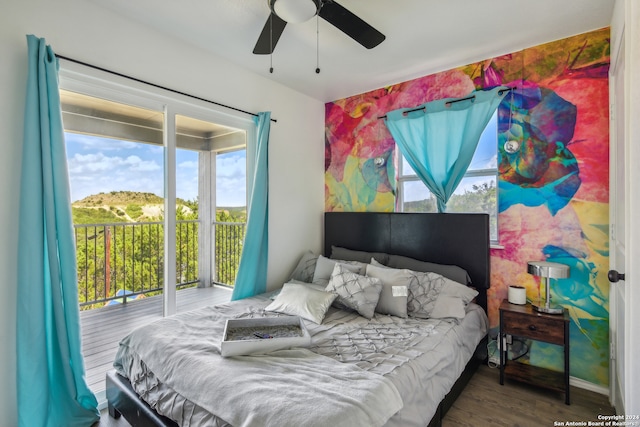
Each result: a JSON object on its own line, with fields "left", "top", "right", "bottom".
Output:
{"left": 74, "top": 220, "right": 245, "bottom": 310}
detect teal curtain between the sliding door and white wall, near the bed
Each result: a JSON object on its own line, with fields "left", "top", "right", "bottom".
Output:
{"left": 231, "top": 112, "right": 271, "bottom": 301}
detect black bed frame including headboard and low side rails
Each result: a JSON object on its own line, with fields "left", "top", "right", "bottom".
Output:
{"left": 106, "top": 212, "right": 490, "bottom": 427}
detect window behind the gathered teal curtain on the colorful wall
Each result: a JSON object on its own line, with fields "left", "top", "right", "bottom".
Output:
{"left": 396, "top": 112, "right": 498, "bottom": 243}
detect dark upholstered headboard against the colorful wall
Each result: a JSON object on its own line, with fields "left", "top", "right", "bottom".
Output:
{"left": 324, "top": 212, "right": 490, "bottom": 310}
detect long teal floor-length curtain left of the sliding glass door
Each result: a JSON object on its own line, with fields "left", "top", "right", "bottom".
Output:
{"left": 16, "top": 35, "right": 99, "bottom": 427}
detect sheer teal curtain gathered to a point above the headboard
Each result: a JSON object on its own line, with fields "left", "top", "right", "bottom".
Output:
{"left": 385, "top": 87, "right": 509, "bottom": 212}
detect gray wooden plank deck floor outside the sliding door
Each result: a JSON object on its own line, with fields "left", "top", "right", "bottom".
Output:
{"left": 80, "top": 286, "right": 231, "bottom": 400}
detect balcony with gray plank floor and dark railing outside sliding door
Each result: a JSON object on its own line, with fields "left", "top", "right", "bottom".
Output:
{"left": 74, "top": 220, "right": 245, "bottom": 400}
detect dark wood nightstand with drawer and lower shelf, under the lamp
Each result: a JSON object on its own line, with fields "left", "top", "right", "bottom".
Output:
{"left": 498, "top": 300, "right": 570, "bottom": 405}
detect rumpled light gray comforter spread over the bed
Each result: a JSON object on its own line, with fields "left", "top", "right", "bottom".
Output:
{"left": 114, "top": 297, "right": 486, "bottom": 427}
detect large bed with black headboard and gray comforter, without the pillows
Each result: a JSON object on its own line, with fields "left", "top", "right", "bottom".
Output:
{"left": 106, "top": 212, "right": 490, "bottom": 427}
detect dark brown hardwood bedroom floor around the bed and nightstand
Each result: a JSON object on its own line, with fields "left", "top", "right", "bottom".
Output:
{"left": 93, "top": 366, "right": 615, "bottom": 427}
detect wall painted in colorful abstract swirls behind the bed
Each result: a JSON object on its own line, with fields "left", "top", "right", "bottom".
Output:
{"left": 325, "top": 28, "right": 609, "bottom": 386}
